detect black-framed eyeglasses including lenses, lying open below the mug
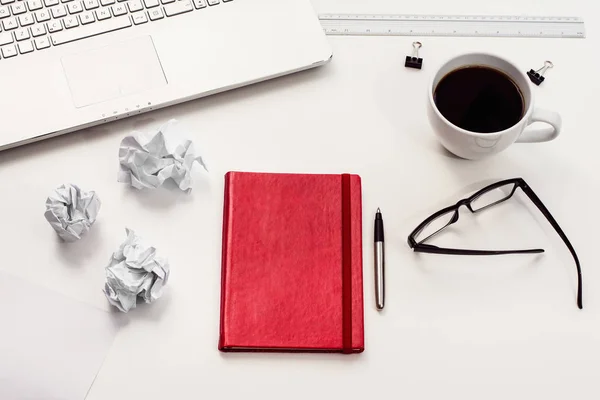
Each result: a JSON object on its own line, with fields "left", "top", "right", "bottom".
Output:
{"left": 408, "top": 178, "right": 583, "bottom": 309}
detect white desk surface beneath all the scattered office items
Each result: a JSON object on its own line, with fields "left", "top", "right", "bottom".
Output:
{"left": 0, "top": 0, "right": 600, "bottom": 400}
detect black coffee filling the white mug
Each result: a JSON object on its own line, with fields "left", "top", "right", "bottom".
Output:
{"left": 433, "top": 66, "right": 524, "bottom": 133}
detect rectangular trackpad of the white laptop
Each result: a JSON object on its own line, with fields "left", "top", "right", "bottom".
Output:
{"left": 62, "top": 36, "right": 167, "bottom": 107}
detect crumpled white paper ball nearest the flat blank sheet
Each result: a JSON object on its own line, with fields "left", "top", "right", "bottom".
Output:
{"left": 104, "top": 229, "right": 170, "bottom": 313}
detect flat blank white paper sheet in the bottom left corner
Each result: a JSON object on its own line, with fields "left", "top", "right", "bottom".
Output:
{"left": 0, "top": 273, "right": 117, "bottom": 400}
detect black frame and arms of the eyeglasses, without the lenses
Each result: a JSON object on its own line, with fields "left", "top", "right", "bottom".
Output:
{"left": 408, "top": 178, "right": 583, "bottom": 309}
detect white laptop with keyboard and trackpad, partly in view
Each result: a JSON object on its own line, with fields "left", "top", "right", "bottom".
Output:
{"left": 0, "top": 0, "right": 332, "bottom": 150}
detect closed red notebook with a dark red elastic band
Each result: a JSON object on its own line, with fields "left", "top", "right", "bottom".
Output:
{"left": 219, "top": 172, "right": 364, "bottom": 353}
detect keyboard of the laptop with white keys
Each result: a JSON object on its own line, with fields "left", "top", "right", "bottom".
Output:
{"left": 0, "top": 0, "right": 232, "bottom": 59}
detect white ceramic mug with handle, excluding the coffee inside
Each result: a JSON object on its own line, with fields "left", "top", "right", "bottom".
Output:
{"left": 427, "top": 53, "right": 562, "bottom": 160}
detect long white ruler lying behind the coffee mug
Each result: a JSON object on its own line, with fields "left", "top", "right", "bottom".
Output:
{"left": 319, "top": 14, "right": 585, "bottom": 38}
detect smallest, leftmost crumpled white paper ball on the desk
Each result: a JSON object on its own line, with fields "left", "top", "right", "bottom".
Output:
{"left": 44, "top": 184, "right": 100, "bottom": 242}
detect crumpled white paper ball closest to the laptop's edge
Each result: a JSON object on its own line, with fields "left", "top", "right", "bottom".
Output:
{"left": 117, "top": 120, "right": 208, "bottom": 193}
